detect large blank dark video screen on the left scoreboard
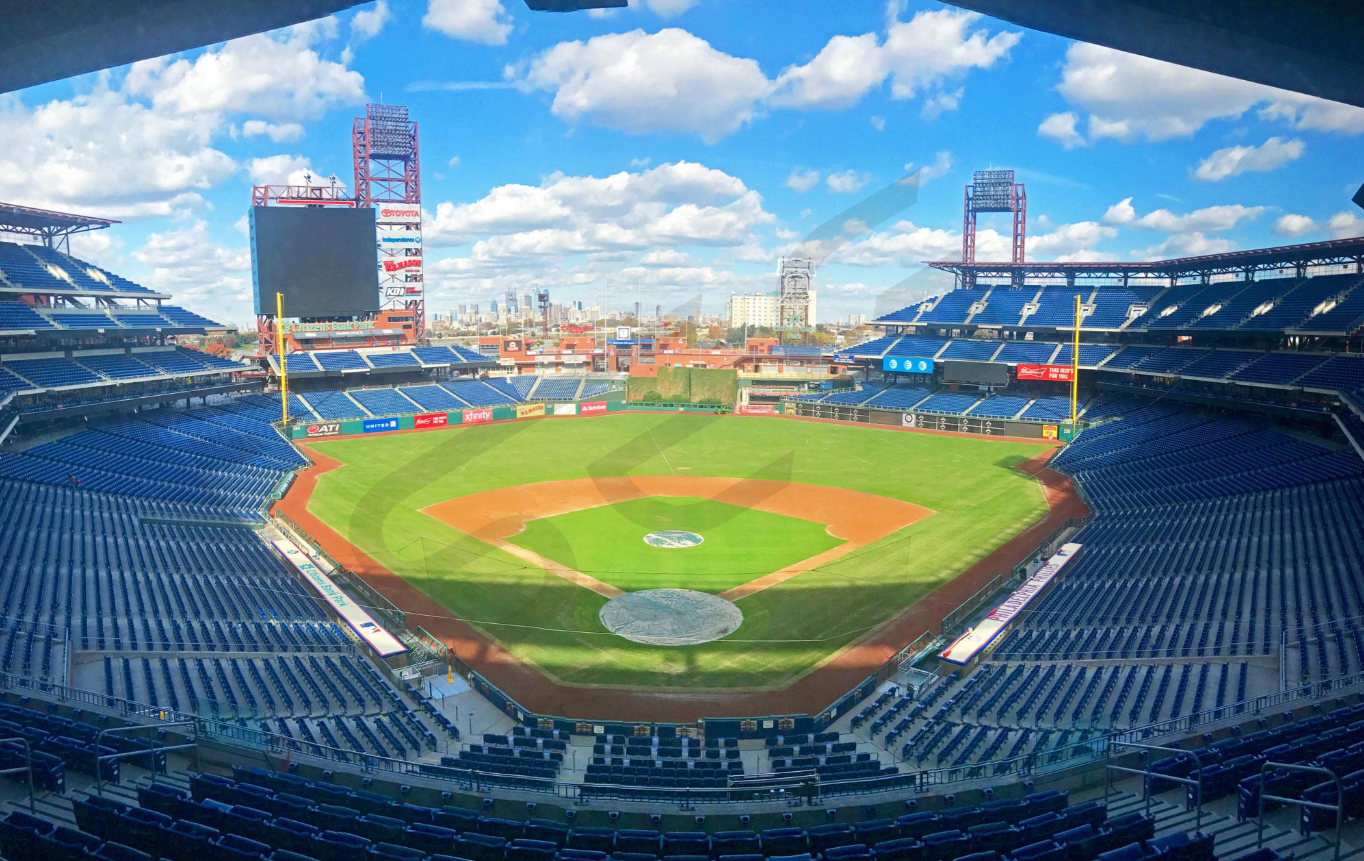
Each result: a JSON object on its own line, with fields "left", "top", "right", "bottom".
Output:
{"left": 251, "top": 206, "right": 379, "bottom": 318}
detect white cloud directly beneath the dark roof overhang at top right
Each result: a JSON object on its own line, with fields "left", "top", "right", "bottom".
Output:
{"left": 1038, "top": 42, "right": 1364, "bottom": 147}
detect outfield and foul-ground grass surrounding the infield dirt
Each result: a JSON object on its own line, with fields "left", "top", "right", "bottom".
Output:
{"left": 310, "top": 413, "right": 1046, "bottom": 689}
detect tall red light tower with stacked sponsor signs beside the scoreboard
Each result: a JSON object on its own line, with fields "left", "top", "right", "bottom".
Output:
{"left": 351, "top": 105, "right": 426, "bottom": 344}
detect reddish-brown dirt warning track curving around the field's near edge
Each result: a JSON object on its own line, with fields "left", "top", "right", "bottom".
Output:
{"left": 274, "top": 416, "right": 1088, "bottom": 723}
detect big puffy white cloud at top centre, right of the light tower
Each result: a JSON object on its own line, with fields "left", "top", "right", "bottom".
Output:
{"left": 521, "top": 29, "right": 769, "bottom": 142}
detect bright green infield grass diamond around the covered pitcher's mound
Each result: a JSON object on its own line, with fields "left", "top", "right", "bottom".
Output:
{"left": 512, "top": 497, "right": 843, "bottom": 594}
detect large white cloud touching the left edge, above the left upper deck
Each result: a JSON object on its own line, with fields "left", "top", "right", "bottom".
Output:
{"left": 0, "top": 86, "right": 236, "bottom": 218}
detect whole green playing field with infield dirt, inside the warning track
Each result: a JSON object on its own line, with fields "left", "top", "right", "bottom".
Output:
{"left": 295, "top": 412, "right": 1048, "bottom": 692}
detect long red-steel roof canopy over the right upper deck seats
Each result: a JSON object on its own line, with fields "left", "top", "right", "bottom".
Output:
{"left": 925, "top": 236, "right": 1364, "bottom": 278}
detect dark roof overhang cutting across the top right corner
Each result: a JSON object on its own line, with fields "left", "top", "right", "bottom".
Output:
{"left": 948, "top": 0, "right": 1364, "bottom": 106}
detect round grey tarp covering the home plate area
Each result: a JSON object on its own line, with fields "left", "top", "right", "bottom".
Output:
{"left": 597, "top": 589, "right": 743, "bottom": 645}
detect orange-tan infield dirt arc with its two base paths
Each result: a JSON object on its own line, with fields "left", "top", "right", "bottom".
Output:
{"left": 421, "top": 475, "right": 933, "bottom": 600}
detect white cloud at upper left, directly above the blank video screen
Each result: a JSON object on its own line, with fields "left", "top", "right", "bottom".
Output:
{"left": 124, "top": 19, "right": 366, "bottom": 119}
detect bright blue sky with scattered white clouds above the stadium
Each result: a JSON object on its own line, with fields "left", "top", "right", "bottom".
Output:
{"left": 0, "top": 0, "right": 1364, "bottom": 323}
